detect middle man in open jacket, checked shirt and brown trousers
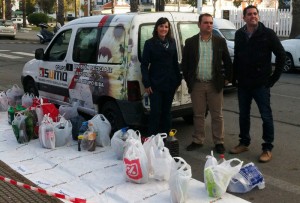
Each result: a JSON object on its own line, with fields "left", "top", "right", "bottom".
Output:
{"left": 181, "top": 13, "right": 232, "bottom": 154}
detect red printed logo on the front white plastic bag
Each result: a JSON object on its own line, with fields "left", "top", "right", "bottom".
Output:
{"left": 124, "top": 158, "right": 143, "bottom": 180}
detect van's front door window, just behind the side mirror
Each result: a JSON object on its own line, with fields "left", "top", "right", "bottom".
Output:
{"left": 45, "top": 30, "right": 72, "bottom": 61}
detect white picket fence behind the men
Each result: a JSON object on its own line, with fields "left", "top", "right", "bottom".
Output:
{"left": 221, "top": 9, "right": 292, "bottom": 37}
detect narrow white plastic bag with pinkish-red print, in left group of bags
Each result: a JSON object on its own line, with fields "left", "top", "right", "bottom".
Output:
{"left": 39, "top": 114, "right": 55, "bottom": 149}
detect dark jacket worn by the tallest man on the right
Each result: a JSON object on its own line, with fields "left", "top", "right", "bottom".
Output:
{"left": 233, "top": 22, "right": 285, "bottom": 88}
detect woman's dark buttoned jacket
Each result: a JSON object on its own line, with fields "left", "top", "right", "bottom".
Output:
{"left": 141, "top": 38, "right": 182, "bottom": 91}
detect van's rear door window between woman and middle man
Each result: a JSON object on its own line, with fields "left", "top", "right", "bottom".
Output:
{"left": 178, "top": 22, "right": 200, "bottom": 50}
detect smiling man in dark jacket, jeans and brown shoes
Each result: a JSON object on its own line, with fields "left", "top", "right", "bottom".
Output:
{"left": 230, "top": 5, "right": 285, "bottom": 162}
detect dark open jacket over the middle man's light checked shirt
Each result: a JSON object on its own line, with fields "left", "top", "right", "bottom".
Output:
{"left": 181, "top": 34, "right": 232, "bottom": 93}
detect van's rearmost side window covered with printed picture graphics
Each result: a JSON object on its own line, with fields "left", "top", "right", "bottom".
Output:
{"left": 97, "top": 24, "right": 126, "bottom": 64}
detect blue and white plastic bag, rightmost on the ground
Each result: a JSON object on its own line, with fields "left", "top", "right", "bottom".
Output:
{"left": 227, "top": 162, "right": 265, "bottom": 193}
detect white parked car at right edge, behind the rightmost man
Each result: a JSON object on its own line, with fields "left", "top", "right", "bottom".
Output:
{"left": 272, "top": 35, "right": 300, "bottom": 72}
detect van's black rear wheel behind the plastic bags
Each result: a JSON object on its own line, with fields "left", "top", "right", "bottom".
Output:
{"left": 101, "top": 101, "right": 126, "bottom": 135}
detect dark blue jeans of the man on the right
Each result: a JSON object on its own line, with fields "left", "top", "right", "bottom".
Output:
{"left": 238, "top": 87, "right": 274, "bottom": 151}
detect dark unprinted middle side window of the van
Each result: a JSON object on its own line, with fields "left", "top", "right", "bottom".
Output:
{"left": 72, "top": 28, "right": 98, "bottom": 63}
